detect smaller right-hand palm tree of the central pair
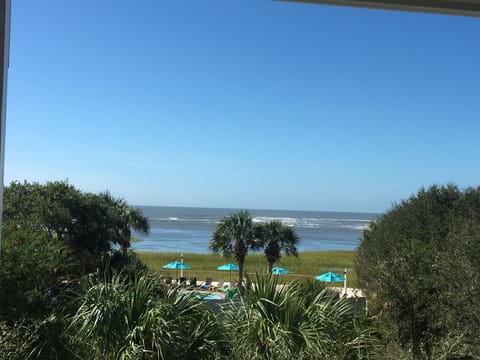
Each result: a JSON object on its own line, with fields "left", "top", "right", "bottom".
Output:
{"left": 257, "top": 220, "right": 298, "bottom": 274}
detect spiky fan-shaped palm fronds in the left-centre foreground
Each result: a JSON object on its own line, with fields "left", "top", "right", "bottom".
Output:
{"left": 67, "top": 274, "right": 222, "bottom": 360}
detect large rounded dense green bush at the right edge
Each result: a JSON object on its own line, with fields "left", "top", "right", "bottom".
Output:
{"left": 356, "top": 185, "right": 480, "bottom": 359}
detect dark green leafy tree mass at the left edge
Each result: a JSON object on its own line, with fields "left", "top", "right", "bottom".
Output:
{"left": 0, "top": 181, "right": 148, "bottom": 322}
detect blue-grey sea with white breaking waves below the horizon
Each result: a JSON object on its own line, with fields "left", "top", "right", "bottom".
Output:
{"left": 132, "top": 206, "right": 379, "bottom": 253}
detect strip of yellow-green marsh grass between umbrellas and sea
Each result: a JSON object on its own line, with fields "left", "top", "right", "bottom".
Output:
{"left": 137, "top": 251, "right": 358, "bottom": 287}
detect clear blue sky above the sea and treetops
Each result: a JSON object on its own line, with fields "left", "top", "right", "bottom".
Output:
{"left": 5, "top": 0, "right": 480, "bottom": 212}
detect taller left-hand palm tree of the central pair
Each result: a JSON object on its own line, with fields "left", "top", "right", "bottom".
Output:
{"left": 209, "top": 210, "right": 263, "bottom": 284}
